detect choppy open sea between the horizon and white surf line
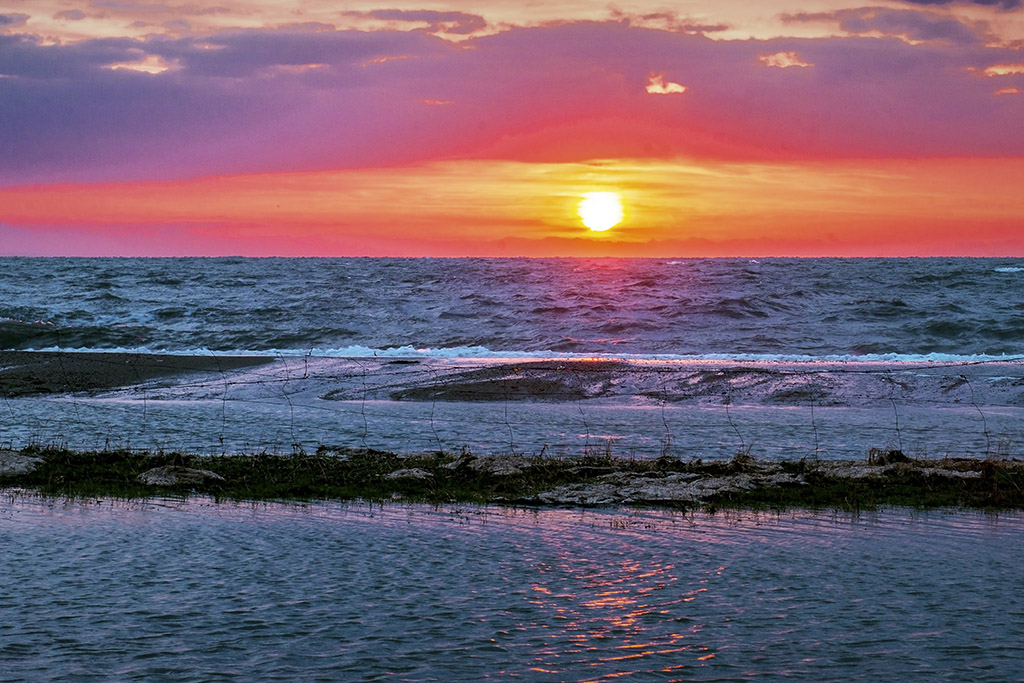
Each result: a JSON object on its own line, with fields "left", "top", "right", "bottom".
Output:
{"left": 0, "top": 258, "right": 1024, "bottom": 360}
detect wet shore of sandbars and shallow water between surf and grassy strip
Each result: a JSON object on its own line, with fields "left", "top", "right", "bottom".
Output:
{"left": 0, "top": 351, "right": 1024, "bottom": 471}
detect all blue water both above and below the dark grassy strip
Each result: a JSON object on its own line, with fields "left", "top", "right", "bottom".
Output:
{"left": 0, "top": 258, "right": 1024, "bottom": 681}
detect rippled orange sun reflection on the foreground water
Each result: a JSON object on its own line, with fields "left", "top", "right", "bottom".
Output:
{"left": 495, "top": 511, "right": 745, "bottom": 680}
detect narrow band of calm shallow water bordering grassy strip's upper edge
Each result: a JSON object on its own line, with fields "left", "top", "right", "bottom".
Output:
{"left": 6, "top": 397, "right": 1024, "bottom": 461}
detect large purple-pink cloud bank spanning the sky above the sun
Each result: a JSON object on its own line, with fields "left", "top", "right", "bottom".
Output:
{"left": 0, "top": 20, "right": 1024, "bottom": 184}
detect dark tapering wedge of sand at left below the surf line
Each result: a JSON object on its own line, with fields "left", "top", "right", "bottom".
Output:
{"left": 0, "top": 351, "right": 273, "bottom": 398}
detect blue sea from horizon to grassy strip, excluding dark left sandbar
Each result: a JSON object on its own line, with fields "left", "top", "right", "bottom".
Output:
{"left": 0, "top": 258, "right": 1024, "bottom": 460}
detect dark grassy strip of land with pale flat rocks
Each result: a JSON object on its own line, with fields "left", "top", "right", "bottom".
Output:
{"left": 0, "top": 447, "right": 1024, "bottom": 511}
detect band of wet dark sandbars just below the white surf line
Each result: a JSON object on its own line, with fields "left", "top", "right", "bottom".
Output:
{"left": 8, "top": 349, "right": 1024, "bottom": 407}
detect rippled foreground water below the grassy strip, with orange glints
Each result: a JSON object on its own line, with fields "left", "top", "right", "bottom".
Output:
{"left": 0, "top": 494, "right": 1024, "bottom": 681}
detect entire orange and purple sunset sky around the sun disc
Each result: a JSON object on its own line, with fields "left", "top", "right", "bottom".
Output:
{"left": 0, "top": 0, "right": 1024, "bottom": 257}
